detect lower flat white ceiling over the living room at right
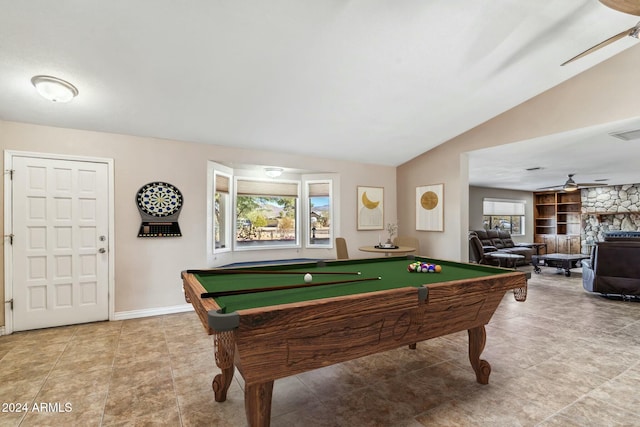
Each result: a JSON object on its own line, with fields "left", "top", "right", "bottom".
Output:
{"left": 468, "top": 117, "right": 640, "bottom": 191}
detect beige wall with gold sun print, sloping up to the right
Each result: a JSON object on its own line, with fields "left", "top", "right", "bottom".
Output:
{"left": 397, "top": 46, "right": 640, "bottom": 260}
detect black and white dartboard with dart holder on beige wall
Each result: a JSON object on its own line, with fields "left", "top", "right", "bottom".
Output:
{"left": 136, "top": 181, "right": 184, "bottom": 237}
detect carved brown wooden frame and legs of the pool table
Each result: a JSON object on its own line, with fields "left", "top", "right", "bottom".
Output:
{"left": 182, "top": 261, "right": 527, "bottom": 427}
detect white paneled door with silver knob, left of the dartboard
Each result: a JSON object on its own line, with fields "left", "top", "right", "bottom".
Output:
{"left": 11, "top": 156, "right": 109, "bottom": 331}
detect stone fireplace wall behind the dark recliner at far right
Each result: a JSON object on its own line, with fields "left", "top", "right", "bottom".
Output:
{"left": 580, "top": 184, "right": 640, "bottom": 253}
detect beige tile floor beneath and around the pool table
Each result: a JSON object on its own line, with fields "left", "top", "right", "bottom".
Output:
{"left": 0, "top": 269, "right": 640, "bottom": 427}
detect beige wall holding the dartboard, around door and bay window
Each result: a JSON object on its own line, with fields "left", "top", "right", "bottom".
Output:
{"left": 0, "top": 121, "right": 396, "bottom": 325}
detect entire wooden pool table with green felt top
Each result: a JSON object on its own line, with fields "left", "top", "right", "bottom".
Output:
{"left": 182, "top": 255, "right": 527, "bottom": 426}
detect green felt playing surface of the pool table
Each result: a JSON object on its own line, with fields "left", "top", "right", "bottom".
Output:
{"left": 193, "top": 256, "right": 512, "bottom": 313}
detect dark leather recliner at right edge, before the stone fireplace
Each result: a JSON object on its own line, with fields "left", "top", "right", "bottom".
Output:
{"left": 582, "top": 232, "right": 640, "bottom": 299}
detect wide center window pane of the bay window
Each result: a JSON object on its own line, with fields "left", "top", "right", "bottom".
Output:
{"left": 235, "top": 178, "right": 299, "bottom": 250}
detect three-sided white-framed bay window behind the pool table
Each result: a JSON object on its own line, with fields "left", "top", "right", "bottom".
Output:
{"left": 206, "top": 161, "right": 339, "bottom": 263}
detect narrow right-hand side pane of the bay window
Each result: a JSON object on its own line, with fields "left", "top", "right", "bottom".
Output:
{"left": 306, "top": 180, "right": 333, "bottom": 248}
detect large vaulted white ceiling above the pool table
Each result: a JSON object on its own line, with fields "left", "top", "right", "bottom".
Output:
{"left": 0, "top": 0, "right": 638, "bottom": 185}
